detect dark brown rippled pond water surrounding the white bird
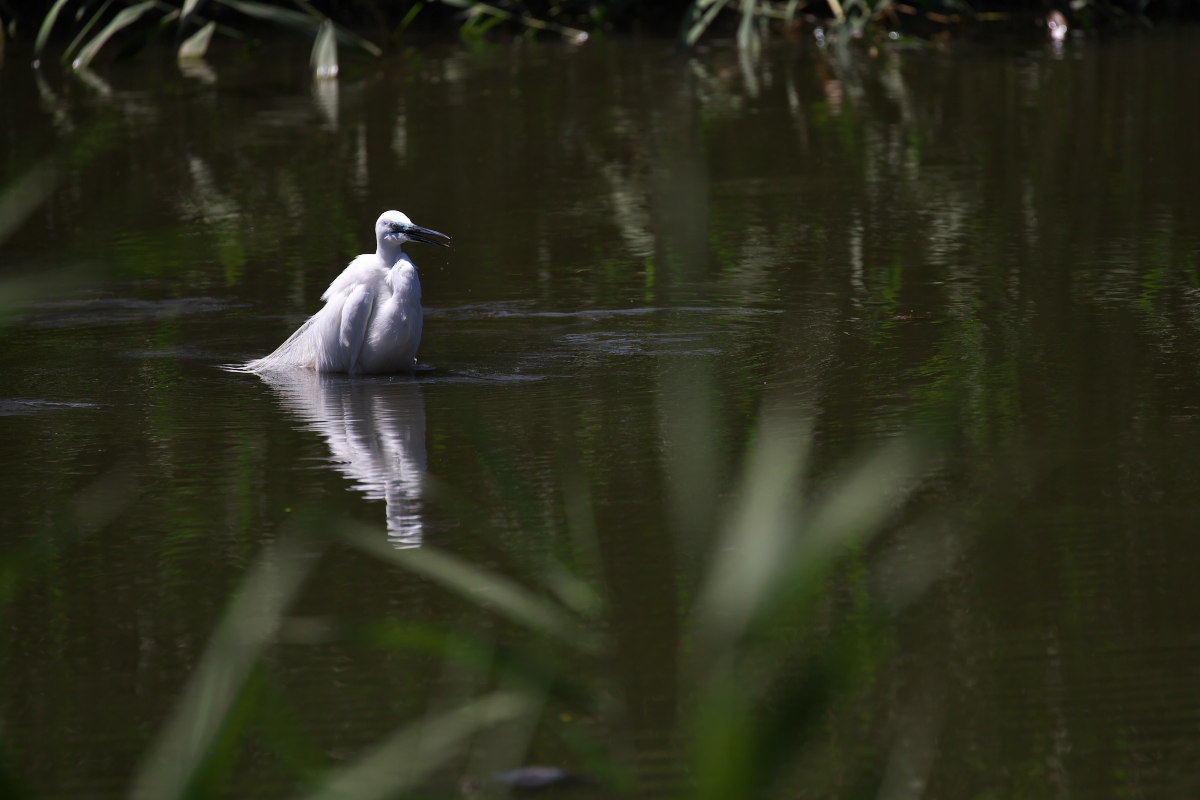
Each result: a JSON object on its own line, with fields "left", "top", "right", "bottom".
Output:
{"left": 0, "top": 25, "right": 1200, "bottom": 798}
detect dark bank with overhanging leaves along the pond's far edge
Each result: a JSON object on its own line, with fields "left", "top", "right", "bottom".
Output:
{"left": 0, "top": 0, "right": 1200, "bottom": 67}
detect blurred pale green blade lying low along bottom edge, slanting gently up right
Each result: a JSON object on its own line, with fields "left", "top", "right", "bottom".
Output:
{"left": 304, "top": 691, "right": 541, "bottom": 800}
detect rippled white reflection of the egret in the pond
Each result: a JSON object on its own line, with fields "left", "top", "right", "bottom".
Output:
{"left": 259, "top": 369, "right": 426, "bottom": 547}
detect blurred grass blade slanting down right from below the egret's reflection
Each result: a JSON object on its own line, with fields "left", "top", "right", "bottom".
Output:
{"left": 349, "top": 531, "right": 594, "bottom": 649}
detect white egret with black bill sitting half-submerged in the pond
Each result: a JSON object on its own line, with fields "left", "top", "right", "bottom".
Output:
{"left": 245, "top": 211, "right": 450, "bottom": 374}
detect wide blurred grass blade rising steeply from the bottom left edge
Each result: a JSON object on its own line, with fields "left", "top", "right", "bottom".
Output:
{"left": 132, "top": 540, "right": 316, "bottom": 800}
